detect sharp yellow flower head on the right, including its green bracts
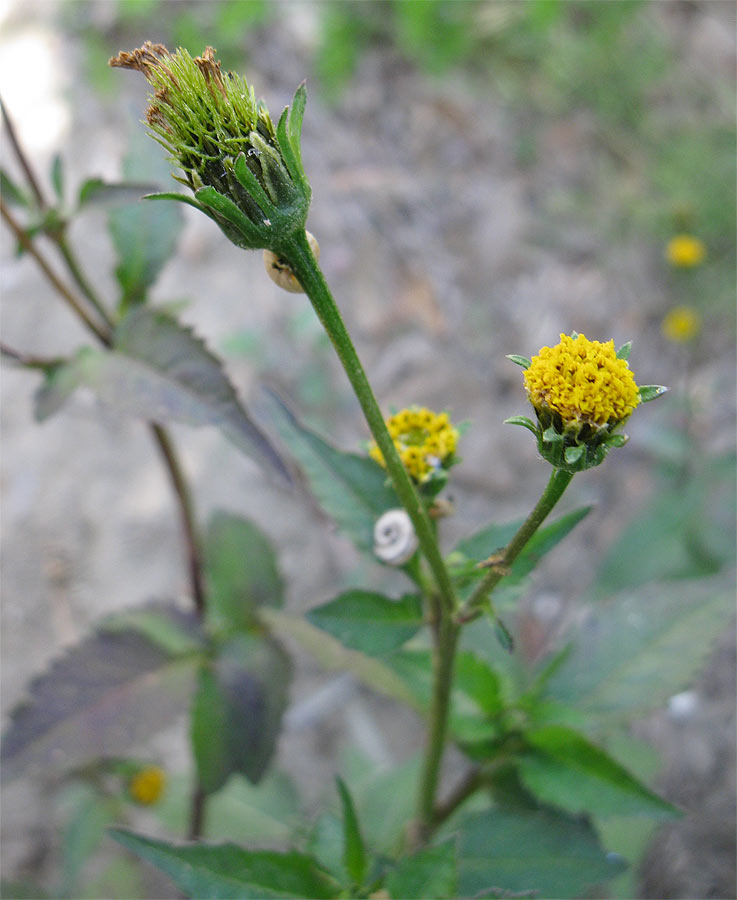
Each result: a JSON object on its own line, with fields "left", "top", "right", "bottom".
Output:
{"left": 507, "top": 332, "right": 666, "bottom": 472}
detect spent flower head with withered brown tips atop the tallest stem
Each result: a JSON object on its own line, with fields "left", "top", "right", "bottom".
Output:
{"left": 110, "top": 41, "right": 311, "bottom": 252}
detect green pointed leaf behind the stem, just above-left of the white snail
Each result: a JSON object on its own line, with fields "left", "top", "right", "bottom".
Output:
{"left": 269, "top": 394, "right": 400, "bottom": 555}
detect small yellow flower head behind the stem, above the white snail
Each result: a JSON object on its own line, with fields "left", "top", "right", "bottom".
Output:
{"left": 369, "top": 406, "right": 458, "bottom": 484}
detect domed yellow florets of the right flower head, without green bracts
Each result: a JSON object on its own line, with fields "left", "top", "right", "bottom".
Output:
{"left": 524, "top": 334, "right": 640, "bottom": 428}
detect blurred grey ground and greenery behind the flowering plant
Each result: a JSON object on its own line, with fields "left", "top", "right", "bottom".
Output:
{"left": 0, "top": 0, "right": 736, "bottom": 897}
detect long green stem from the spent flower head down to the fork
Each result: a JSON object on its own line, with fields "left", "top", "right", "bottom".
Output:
{"left": 277, "top": 231, "right": 456, "bottom": 612}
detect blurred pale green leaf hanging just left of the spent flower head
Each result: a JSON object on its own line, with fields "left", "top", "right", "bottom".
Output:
{"left": 108, "top": 139, "right": 184, "bottom": 311}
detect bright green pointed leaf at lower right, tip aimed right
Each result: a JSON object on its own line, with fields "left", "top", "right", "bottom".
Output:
{"left": 519, "top": 725, "right": 678, "bottom": 818}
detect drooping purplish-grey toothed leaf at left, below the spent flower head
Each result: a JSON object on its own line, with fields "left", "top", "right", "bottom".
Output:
{"left": 36, "top": 307, "right": 290, "bottom": 480}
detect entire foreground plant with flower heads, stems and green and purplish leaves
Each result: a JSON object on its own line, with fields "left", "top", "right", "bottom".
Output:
{"left": 3, "top": 43, "right": 708, "bottom": 898}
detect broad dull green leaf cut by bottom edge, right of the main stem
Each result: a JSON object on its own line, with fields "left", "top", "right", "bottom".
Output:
{"left": 458, "top": 808, "right": 624, "bottom": 898}
